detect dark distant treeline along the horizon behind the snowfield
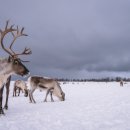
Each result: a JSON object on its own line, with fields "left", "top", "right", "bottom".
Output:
{"left": 57, "top": 77, "right": 130, "bottom": 82}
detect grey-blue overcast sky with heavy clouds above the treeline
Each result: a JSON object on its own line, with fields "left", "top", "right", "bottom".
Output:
{"left": 0, "top": 0, "right": 130, "bottom": 78}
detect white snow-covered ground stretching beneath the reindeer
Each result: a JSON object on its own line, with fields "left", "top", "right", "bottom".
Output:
{"left": 0, "top": 82, "right": 130, "bottom": 130}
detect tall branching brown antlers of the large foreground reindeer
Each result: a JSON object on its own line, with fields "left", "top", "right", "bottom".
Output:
{"left": 0, "top": 20, "right": 32, "bottom": 57}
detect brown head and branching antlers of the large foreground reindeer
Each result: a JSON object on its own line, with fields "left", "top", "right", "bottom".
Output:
{"left": 0, "top": 21, "right": 32, "bottom": 76}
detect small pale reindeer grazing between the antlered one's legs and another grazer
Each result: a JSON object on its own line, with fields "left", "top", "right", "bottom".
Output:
{"left": 13, "top": 80, "right": 28, "bottom": 97}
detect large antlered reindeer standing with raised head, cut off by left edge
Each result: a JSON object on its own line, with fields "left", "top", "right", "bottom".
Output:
{"left": 0, "top": 21, "right": 31, "bottom": 114}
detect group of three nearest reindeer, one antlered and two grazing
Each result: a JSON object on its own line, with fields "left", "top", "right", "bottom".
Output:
{"left": 0, "top": 21, "right": 65, "bottom": 115}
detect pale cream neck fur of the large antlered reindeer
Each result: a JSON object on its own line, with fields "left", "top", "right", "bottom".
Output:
{"left": 0, "top": 58, "right": 14, "bottom": 88}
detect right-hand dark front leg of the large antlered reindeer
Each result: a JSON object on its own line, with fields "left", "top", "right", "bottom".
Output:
{"left": 4, "top": 76, "right": 11, "bottom": 110}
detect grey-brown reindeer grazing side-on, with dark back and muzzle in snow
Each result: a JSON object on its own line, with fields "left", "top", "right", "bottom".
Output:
{"left": 28, "top": 76, "right": 65, "bottom": 103}
